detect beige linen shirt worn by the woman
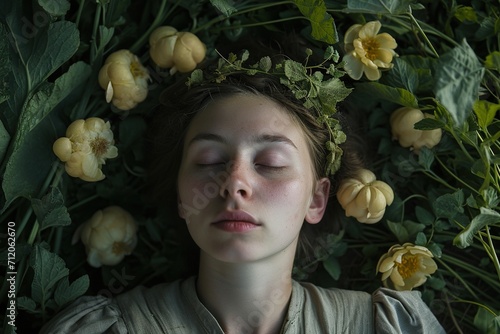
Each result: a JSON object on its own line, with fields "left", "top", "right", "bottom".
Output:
{"left": 40, "top": 277, "right": 444, "bottom": 334}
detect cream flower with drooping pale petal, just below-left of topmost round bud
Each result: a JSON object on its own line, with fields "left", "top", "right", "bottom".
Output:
{"left": 99, "top": 50, "right": 150, "bottom": 110}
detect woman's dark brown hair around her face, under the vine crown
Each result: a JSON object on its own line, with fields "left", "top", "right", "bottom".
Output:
{"left": 147, "top": 43, "right": 368, "bottom": 266}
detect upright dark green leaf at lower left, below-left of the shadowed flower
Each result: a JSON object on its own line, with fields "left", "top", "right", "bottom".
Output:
{"left": 31, "top": 244, "right": 69, "bottom": 303}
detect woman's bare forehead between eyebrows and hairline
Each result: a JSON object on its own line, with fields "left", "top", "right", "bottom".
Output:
{"left": 186, "top": 94, "right": 304, "bottom": 140}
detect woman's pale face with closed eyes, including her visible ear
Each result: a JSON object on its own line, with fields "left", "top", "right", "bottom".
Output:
{"left": 178, "top": 94, "right": 329, "bottom": 262}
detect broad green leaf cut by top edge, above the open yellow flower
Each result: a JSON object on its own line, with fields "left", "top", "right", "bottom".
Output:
{"left": 347, "top": 0, "right": 413, "bottom": 14}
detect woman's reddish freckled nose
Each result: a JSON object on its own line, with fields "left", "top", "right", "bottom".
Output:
{"left": 220, "top": 161, "right": 252, "bottom": 199}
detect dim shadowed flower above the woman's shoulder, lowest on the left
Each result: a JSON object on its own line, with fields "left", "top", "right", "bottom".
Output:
{"left": 76, "top": 206, "right": 137, "bottom": 268}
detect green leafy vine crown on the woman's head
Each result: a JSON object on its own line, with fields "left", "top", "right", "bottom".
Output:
{"left": 186, "top": 46, "right": 352, "bottom": 175}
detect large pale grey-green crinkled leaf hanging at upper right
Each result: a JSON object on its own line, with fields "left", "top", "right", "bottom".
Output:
{"left": 434, "top": 40, "right": 484, "bottom": 127}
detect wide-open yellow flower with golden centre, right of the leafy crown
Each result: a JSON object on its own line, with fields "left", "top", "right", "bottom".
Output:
{"left": 343, "top": 21, "right": 398, "bottom": 80}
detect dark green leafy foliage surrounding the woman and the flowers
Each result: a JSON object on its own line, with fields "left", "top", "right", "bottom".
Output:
{"left": 0, "top": 0, "right": 500, "bottom": 333}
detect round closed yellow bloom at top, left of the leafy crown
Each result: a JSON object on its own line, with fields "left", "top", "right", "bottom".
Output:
{"left": 149, "top": 26, "right": 207, "bottom": 74}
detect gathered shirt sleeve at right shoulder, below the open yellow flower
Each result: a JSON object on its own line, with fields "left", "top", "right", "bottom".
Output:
{"left": 372, "top": 288, "right": 445, "bottom": 334}
